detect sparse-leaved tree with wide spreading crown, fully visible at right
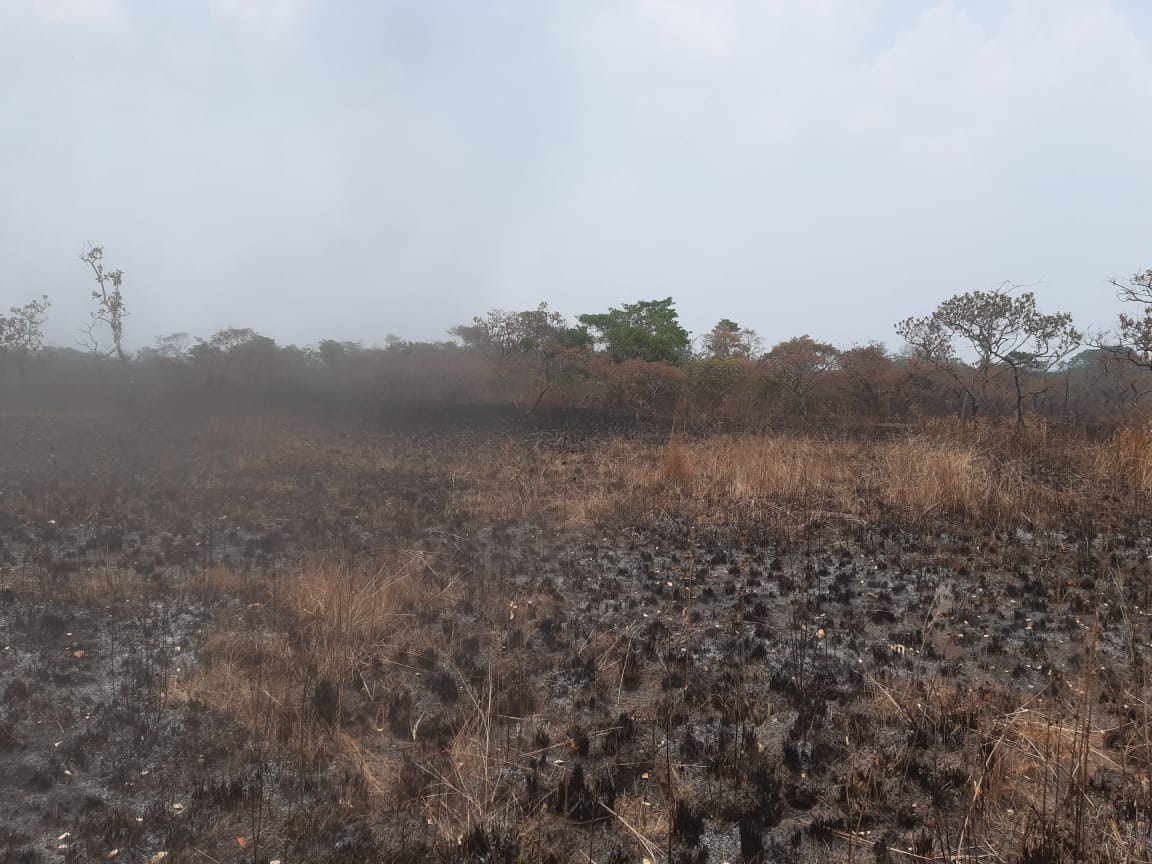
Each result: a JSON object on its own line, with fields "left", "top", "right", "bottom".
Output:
{"left": 896, "top": 282, "right": 1083, "bottom": 426}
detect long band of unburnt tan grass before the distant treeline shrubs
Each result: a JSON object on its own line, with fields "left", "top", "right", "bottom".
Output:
{"left": 150, "top": 420, "right": 1152, "bottom": 539}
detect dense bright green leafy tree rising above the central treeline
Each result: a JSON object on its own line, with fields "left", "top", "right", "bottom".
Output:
{"left": 577, "top": 297, "right": 689, "bottom": 365}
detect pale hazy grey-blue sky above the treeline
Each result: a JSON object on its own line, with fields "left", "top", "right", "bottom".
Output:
{"left": 0, "top": 0, "right": 1152, "bottom": 347}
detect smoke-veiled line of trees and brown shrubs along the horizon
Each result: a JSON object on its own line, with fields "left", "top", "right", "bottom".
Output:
{"left": 0, "top": 247, "right": 1152, "bottom": 429}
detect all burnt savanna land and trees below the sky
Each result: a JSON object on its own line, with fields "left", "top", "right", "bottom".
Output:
{"left": 0, "top": 249, "right": 1152, "bottom": 864}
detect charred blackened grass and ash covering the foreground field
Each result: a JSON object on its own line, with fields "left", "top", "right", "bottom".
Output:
{"left": 0, "top": 415, "right": 1152, "bottom": 864}
